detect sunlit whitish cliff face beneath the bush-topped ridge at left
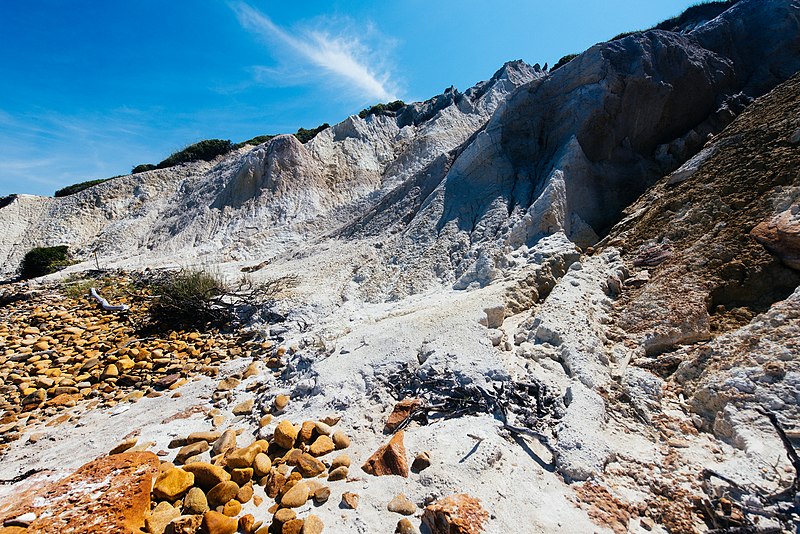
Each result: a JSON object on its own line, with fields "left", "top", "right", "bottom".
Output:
{"left": 0, "top": 61, "right": 545, "bottom": 276}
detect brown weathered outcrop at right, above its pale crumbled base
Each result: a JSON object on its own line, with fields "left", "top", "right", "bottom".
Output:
{"left": 607, "top": 71, "right": 800, "bottom": 354}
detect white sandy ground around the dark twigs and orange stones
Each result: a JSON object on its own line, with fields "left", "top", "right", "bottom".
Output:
{"left": 0, "top": 232, "right": 790, "bottom": 533}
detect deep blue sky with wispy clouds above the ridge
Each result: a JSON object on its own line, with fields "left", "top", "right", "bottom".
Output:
{"left": 0, "top": 0, "right": 695, "bottom": 196}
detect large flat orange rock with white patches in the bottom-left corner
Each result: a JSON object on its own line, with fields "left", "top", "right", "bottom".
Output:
{"left": 0, "top": 452, "right": 159, "bottom": 534}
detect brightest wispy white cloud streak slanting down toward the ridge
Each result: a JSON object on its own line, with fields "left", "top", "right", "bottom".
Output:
{"left": 231, "top": 2, "right": 398, "bottom": 101}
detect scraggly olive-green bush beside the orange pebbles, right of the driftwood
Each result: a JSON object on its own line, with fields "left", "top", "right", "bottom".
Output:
{"left": 150, "top": 269, "right": 232, "bottom": 329}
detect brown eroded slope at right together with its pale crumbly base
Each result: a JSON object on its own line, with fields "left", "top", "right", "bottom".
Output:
{"left": 603, "top": 71, "right": 800, "bottom": 452}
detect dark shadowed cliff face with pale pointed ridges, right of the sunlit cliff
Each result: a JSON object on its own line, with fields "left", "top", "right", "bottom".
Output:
{"left": 340, "top": 2, "right": 800, "bottom": 300}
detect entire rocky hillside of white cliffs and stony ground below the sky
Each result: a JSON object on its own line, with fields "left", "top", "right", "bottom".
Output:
{"left": 0, "top": 0, "right": 800, "bottom": 534}
